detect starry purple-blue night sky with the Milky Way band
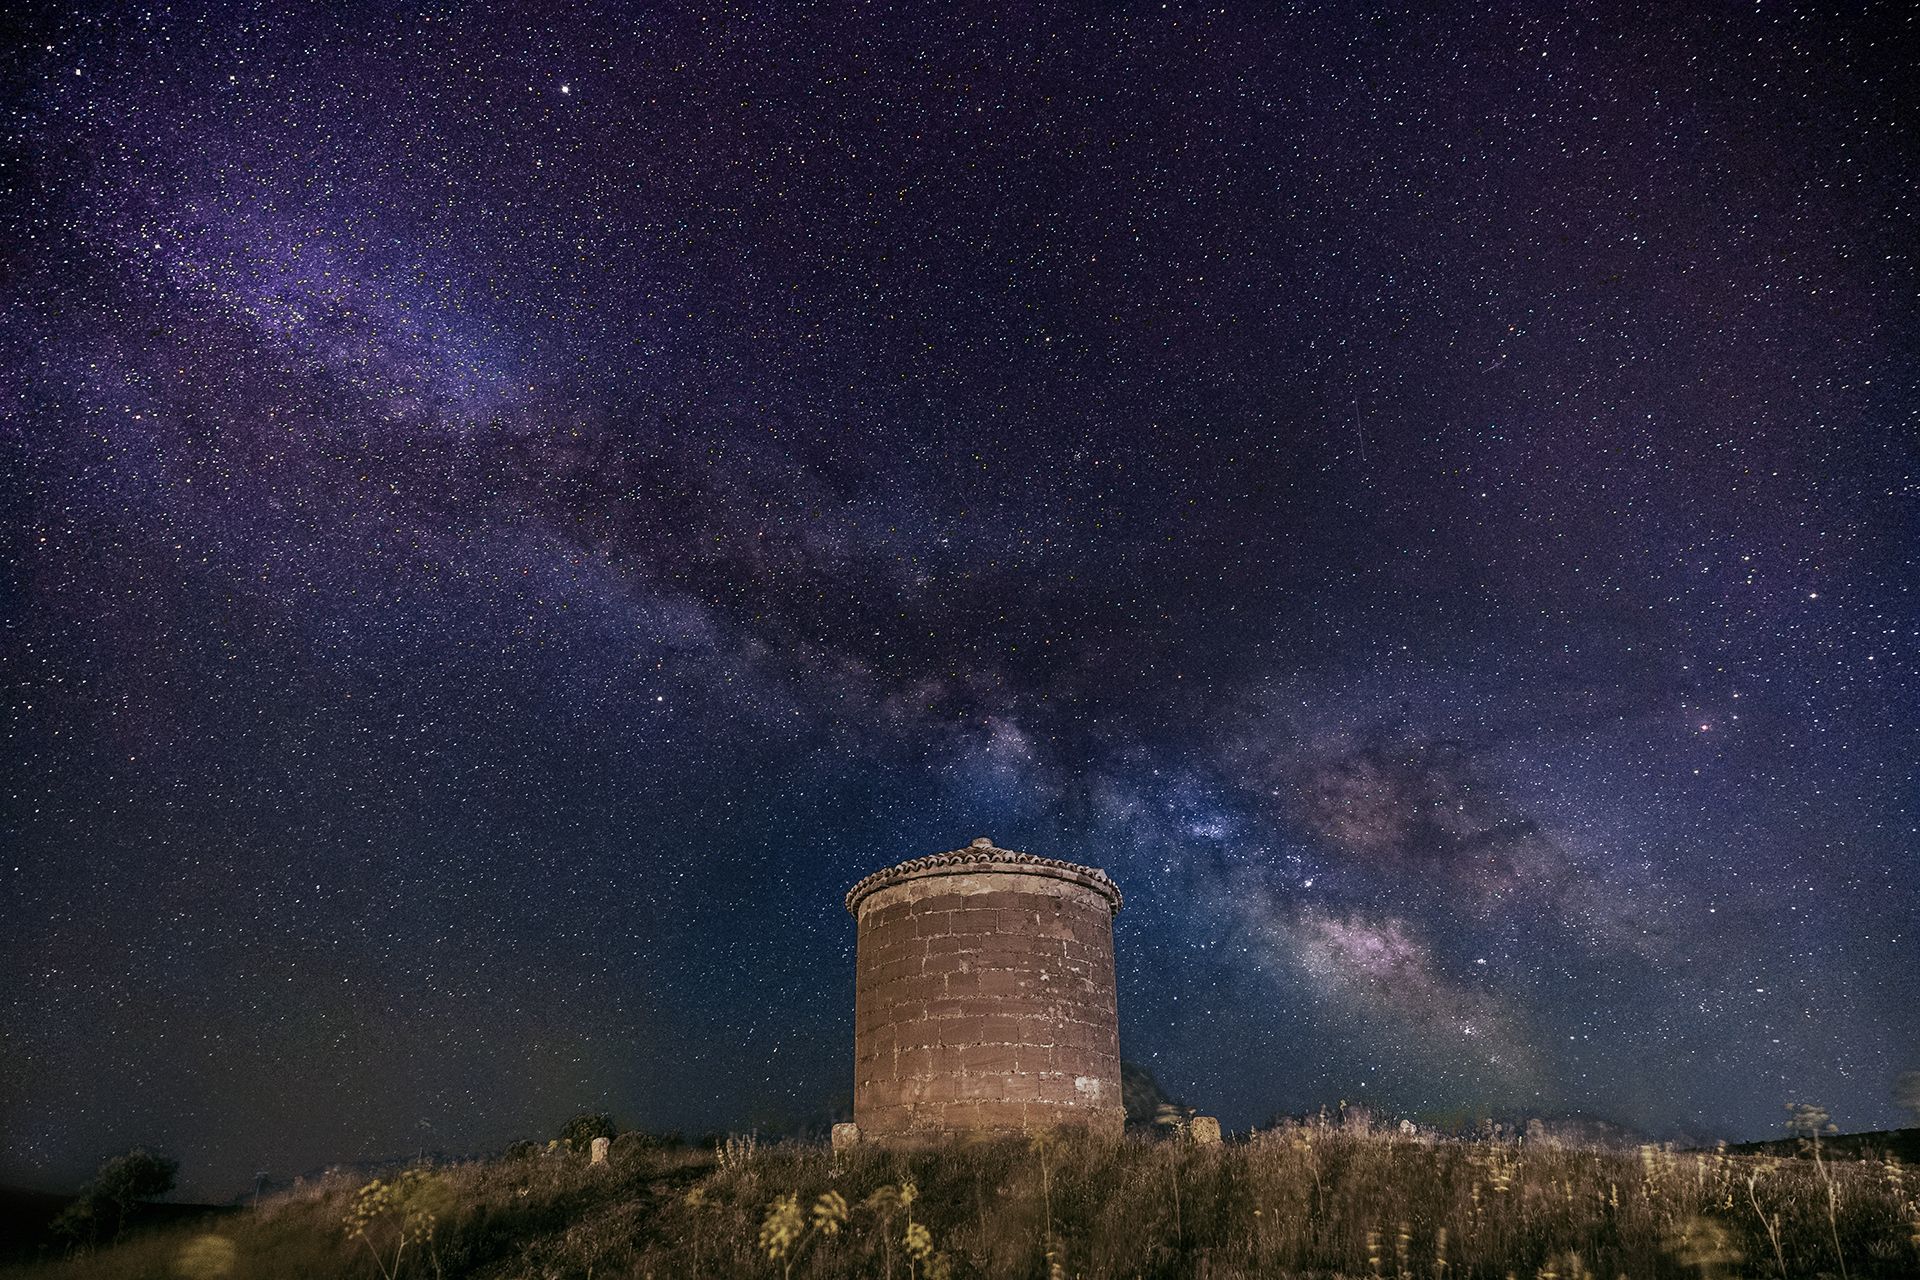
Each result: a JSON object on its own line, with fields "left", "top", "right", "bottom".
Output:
{"left": 0, "top": 2, "right": 1920, "bottom": 1197}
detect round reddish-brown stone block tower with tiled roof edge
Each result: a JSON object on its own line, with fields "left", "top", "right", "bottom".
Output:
{"left": 847, "top": 837, "right": 1125, "bottom": 1142}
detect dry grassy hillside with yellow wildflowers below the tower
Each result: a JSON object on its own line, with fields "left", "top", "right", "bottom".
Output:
{"left": 4, "top": 1123, "right": 1920, "bottom": 1280}
